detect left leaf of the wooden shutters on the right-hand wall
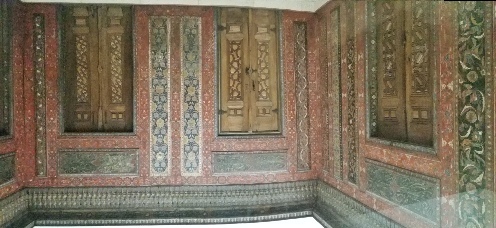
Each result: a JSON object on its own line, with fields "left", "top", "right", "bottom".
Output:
{"left": 376, "top": 1, "right": 406, "bottom": 141}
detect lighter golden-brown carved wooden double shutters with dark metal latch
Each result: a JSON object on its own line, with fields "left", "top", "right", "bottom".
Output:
{"left": 218, "top": 8, "right": 279, "bottom": 133}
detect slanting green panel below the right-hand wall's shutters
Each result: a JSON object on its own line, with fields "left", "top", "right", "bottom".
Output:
{"left": 366, "top": 160, "right": 441, "bottom": 223}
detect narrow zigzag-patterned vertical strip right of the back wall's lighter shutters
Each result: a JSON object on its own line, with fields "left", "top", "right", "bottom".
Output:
{"left": 293, "top": 22, "right": 310, "bottom": 170}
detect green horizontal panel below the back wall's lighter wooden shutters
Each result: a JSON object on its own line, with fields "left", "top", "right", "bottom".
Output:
{"left": 212, "top": 151, "right": 288, "bottom": 173}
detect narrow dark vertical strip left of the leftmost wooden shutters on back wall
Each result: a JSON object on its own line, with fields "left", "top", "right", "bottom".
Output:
{"left": 33, "top": 14, "right": 47, "bottom": 176}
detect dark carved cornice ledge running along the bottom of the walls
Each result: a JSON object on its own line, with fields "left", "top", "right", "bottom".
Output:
{"left": 0, "top": 181, "right": 401, "bottom": 227}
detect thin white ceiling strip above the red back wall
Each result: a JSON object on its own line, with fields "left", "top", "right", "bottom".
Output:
{"left": 21, "top": 0, "right": 329, "bottom": 12}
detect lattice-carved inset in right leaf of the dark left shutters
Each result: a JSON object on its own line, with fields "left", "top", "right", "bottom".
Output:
{"left": 110, "top": 35, "right": 122, "bottom": 104}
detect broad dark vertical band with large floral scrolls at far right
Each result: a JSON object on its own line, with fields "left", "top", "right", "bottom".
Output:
{"left": 457, "top": 2, "right": 494, "bottom": 227}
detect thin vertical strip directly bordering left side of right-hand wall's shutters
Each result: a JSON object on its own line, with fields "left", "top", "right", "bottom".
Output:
{"left": 366, "top": 1, "right": 378, "bottom": 137}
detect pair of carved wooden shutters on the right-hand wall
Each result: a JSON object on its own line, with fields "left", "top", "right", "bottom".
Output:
{"left": 372, "top": 1, "right": 435, "bottom": 145}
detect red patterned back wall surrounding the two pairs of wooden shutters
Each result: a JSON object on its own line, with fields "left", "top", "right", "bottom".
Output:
{"left": 0, "top": 4, "right": 319, "bottom": 192}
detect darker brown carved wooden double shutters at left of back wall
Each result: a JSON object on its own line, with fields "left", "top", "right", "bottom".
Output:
{"left": 62, "top": 6, "right": 133, "bottom": 132}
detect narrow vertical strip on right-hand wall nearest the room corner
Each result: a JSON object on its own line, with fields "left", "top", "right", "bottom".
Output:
{"left": 328, "top": 8, "right": 343, "bottom": 179}
